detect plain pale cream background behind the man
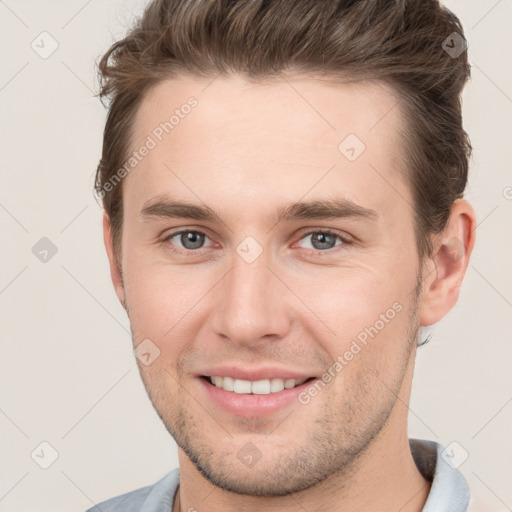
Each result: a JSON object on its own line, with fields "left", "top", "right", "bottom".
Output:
{"left": 0, "top": 0, "right": 512, "bottom": 512}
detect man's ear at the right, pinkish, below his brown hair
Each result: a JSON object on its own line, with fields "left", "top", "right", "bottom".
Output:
{"left": 419, "top": 199, "right": 476, "bottom": 326}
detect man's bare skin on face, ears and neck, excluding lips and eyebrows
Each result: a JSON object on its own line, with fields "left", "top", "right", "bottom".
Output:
{"left": 104, "top": 76, "right": 476, "bottom": 512}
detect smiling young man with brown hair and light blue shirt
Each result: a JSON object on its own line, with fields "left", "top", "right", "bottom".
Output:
{"left": 90, "top": 0, "right": 476, "bottom": 512}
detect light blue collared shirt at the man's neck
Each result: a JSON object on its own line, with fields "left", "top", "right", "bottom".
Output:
{"left": 86, "top": 439, "right": 471, "bottom": 512}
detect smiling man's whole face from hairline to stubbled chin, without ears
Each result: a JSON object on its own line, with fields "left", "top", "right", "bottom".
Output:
{"left": 114, "top": 77, "right": 426, "bottom": 496}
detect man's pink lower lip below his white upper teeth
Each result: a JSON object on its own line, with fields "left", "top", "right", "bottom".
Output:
{"left": 199, "top": 378, "right": 313, "bottom": 418}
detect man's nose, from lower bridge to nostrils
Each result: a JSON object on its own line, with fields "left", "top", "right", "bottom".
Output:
{"left": 212, "top": 254, "right": 293, "bottom": 345}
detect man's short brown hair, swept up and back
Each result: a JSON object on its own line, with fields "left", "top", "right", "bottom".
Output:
{"left": 95, "top": 0, "right": 471, "bottom": 262}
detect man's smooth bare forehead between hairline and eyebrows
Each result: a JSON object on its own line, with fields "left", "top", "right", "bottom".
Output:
{"left": 125, "top": 76, "right": 408, "bottom": 224}
